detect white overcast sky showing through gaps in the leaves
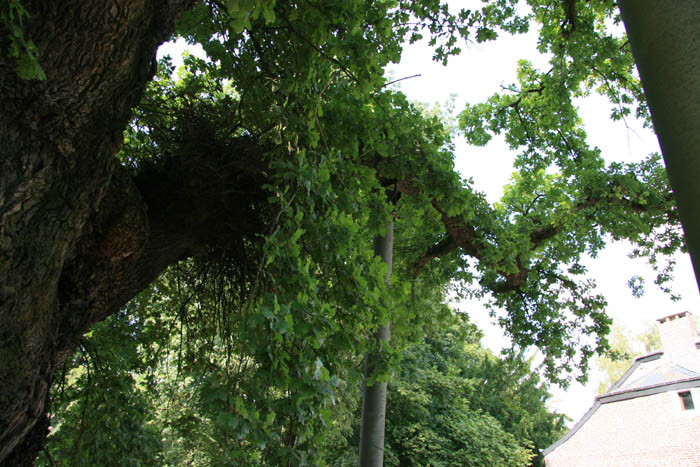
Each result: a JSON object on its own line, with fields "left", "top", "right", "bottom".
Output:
{"left": 391, "top": 21, "right": 700, "bottom": 423}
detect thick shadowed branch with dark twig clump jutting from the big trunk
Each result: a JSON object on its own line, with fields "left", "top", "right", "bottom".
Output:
{"left": 59, "top": 138, "right": 271, "bottom": 358}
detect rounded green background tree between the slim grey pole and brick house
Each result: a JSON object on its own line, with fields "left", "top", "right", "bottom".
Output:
{"left": 325, "top": 315, "right": 564, "bottom": 466}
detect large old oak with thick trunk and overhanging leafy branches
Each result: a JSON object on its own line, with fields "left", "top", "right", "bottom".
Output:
{"left": 0, "top": 0, "right": 685, "bottom": 465}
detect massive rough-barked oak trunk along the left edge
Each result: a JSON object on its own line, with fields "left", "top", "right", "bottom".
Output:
{"left": 0, "top": 0, "right": 192, "bottom": 466}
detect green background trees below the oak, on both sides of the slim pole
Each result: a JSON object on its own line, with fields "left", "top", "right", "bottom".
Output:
{"left": 39, "top": 290, "right": 562, "bottom": 466}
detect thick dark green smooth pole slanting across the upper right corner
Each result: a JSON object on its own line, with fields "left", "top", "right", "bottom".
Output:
{"left": 618, "top": 0, "right": 700, "bottom": 286}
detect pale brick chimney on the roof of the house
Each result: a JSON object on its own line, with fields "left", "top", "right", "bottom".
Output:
{"left": 657, "top": 311, "right": 700, "bottom": 372}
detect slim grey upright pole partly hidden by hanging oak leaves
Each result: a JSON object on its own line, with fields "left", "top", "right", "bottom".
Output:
{"left": 358, "top": 221, "right": 394, "bottom": 467}
